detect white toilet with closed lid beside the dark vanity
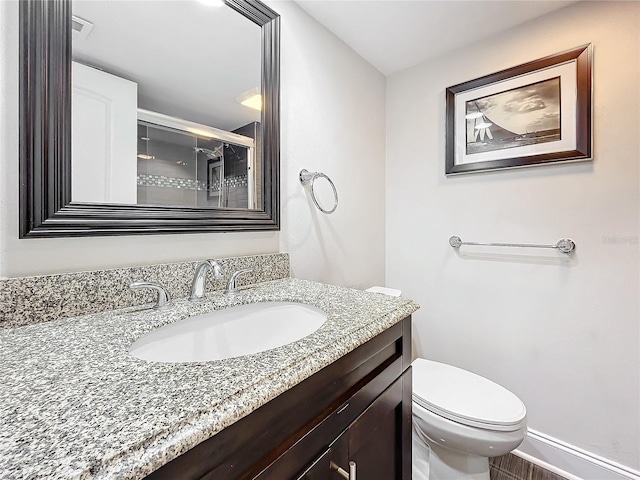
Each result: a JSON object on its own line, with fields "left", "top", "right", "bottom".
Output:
{"left": 411, "top": 358, "right": 527, "bottom": 480}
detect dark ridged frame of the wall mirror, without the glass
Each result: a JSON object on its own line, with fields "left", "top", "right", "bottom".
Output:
{"left": 19, "top": 0, "right": 280, "bottom": 238}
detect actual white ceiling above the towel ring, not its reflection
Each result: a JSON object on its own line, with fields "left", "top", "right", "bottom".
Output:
{"left": 295, "top": 0, "right": 578, "bottom": 75}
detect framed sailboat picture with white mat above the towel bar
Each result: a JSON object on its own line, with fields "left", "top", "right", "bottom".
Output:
{"left": 445, "top": 45, "right": 592, "bottom": 175}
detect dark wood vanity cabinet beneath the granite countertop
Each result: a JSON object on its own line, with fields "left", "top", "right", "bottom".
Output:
{"left": 147, "top": 317, "right": 411, "bottom": 480}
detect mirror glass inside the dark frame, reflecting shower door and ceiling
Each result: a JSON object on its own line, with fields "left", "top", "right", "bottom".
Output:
{"left": 71, "top": 0, "right": 264, "bottom": 210}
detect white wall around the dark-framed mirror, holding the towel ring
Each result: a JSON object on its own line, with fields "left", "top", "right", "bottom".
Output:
{"left": 0, "top": 1, "right": 385, "bottom": 286}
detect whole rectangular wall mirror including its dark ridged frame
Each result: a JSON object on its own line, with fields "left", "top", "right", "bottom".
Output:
{"left": 19, "top": 0, "right": 280, "bottom": 238}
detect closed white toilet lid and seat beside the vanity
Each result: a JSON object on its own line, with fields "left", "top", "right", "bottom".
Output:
{"left": 411, "top": 358, "right": 527, "bottom": 432}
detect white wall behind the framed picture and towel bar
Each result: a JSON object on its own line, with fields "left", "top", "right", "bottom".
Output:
{"left": 386, "top": 2, "right": 640, "bottom": 469}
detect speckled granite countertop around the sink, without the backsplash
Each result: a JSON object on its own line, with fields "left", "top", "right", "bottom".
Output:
{"left": 0, "top": 278, "right": 418, "bottom": 479}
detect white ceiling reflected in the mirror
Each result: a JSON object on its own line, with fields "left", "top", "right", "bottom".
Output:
{"left": 74, "top": 0, "right": 262, "bottom": 130}
